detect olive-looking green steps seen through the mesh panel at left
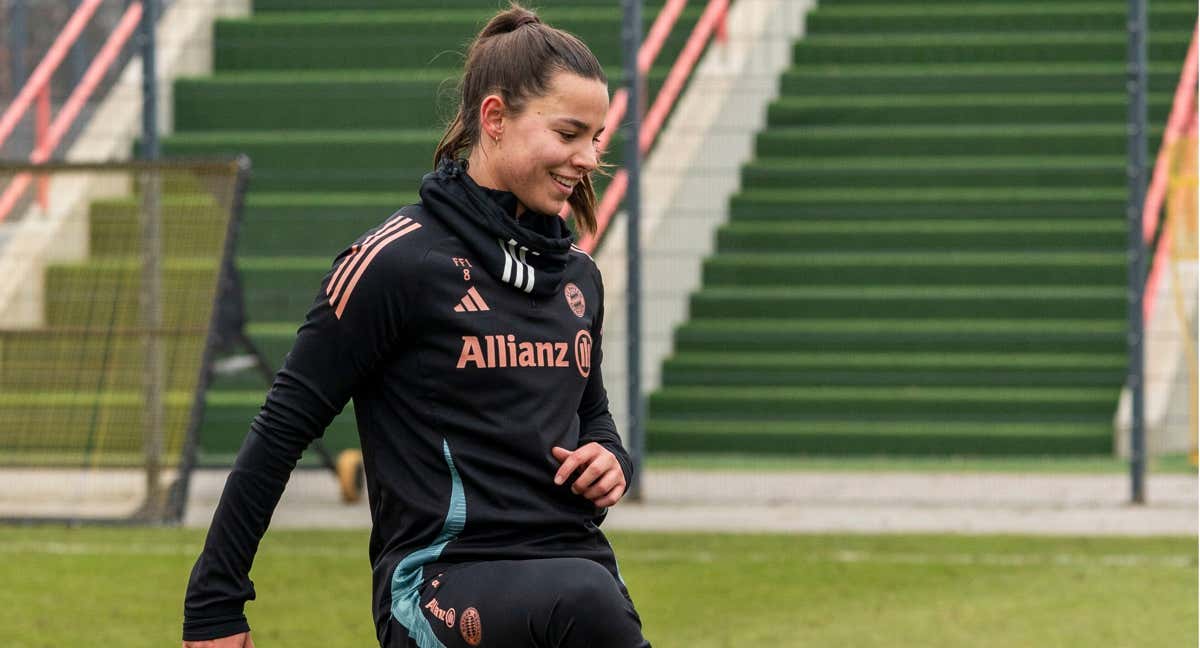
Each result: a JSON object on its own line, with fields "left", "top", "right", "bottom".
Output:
{"left": 0, "top": 172, "right": 232, "bottom": 468}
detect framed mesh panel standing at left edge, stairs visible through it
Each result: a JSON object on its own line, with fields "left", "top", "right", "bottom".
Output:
{"left": 0, "top": 162, "right": 247, "bottom": 522}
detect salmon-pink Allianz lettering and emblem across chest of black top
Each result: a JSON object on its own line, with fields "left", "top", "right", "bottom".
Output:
{"left": 457, "top": 329, "right": 592, "bottom": 378}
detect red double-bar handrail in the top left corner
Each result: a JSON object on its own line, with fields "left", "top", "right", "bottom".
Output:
{"left": 0, "top": 0, "right": 142, "bottom": 222}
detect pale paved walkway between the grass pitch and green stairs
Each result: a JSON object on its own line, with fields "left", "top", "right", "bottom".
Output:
{"left": 185, "top": 469, "right": 1198, "bottom": 535}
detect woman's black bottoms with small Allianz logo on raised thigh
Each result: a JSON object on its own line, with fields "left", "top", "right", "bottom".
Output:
{"left": 380, "top": 558, "right": 650, "bottom": 648}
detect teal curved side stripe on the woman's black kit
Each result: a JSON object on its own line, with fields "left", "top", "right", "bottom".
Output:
{"left": 391, "top": 439, "right": 467, "bottom": 648}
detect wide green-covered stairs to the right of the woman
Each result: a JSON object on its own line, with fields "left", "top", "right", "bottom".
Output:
{"left": 647, "top": 0, "right": 1196, "bottom": 456}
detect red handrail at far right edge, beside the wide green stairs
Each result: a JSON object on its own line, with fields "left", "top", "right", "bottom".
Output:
{"left": 1141, "top": 24, "right": 1200, "bottom": 328}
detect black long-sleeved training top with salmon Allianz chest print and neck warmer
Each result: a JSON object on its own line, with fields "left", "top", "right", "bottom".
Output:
{"left": 184, "top": 161, "right": 630, "bottom": 643}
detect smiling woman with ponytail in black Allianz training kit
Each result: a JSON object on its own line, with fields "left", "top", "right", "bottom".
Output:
{"left": 184, "top": 6, "right": 649, "bottom": 648}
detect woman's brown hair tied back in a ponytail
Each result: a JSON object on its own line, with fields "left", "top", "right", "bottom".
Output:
{"left": 433, "top": 2, "right": 608, "bottom": 233}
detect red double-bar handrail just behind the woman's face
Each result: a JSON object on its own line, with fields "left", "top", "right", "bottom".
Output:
{"left": 573, "top": 0, "right": 730, "bottom": 254}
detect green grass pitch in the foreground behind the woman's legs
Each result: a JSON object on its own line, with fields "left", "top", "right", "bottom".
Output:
{"left": 0, "top": 527, "right": 1198, "bottom": 648}
